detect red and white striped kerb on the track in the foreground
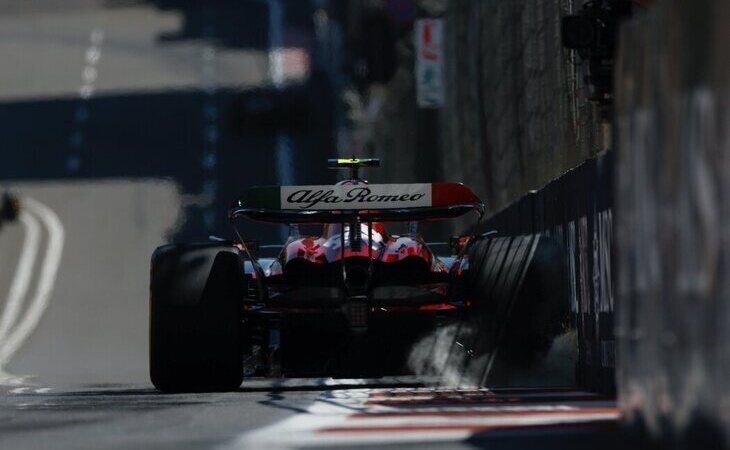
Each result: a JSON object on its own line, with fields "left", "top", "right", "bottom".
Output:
{"left": 226, "top": 388, "right": 618, "bottom": 450}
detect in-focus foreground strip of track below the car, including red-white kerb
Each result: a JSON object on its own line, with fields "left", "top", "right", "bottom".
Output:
{"left": 0, "top": 380, "right": 639, "bottom": 450}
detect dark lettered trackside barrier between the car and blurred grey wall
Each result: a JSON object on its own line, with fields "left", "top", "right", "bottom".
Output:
{"left": 485, "top": 152, "right": 615, "bottom": 393}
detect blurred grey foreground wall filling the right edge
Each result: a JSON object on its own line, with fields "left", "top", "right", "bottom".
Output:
{"left": 616, "top": 0, "right": 730, "bottom": 448}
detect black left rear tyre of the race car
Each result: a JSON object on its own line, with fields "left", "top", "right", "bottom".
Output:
{"left": 150, "top": 243, "right": 245, "bottom": 392}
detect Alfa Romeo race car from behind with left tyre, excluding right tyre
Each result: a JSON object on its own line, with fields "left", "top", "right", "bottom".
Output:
{"left": 150, "top": 158, "right": 484, "bottom": 391}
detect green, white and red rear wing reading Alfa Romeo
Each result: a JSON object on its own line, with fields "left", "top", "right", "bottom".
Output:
{"left": 229, "top": 183, "right": 484, "bottom": 223}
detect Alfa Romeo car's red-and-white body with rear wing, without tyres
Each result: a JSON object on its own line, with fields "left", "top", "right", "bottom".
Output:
{"left": 230, "top": 162, "right": 483, "bottom": 373}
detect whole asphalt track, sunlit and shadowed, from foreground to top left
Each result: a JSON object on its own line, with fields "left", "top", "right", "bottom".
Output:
{"left": 0, "top": 0, "right": 644, "bottom": 449}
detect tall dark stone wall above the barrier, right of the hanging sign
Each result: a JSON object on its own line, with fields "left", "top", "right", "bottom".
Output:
{"left": 437, "top": 0, "right": 609, "bottom": 212}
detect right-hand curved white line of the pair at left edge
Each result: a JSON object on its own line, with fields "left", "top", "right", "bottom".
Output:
{"left": 0, "top": 198, "right": 65, "bottom": 367}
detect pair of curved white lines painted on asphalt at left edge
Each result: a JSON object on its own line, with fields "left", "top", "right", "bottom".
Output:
{"left": 0, "top": 197, "right": 65, "bottom": 384}
